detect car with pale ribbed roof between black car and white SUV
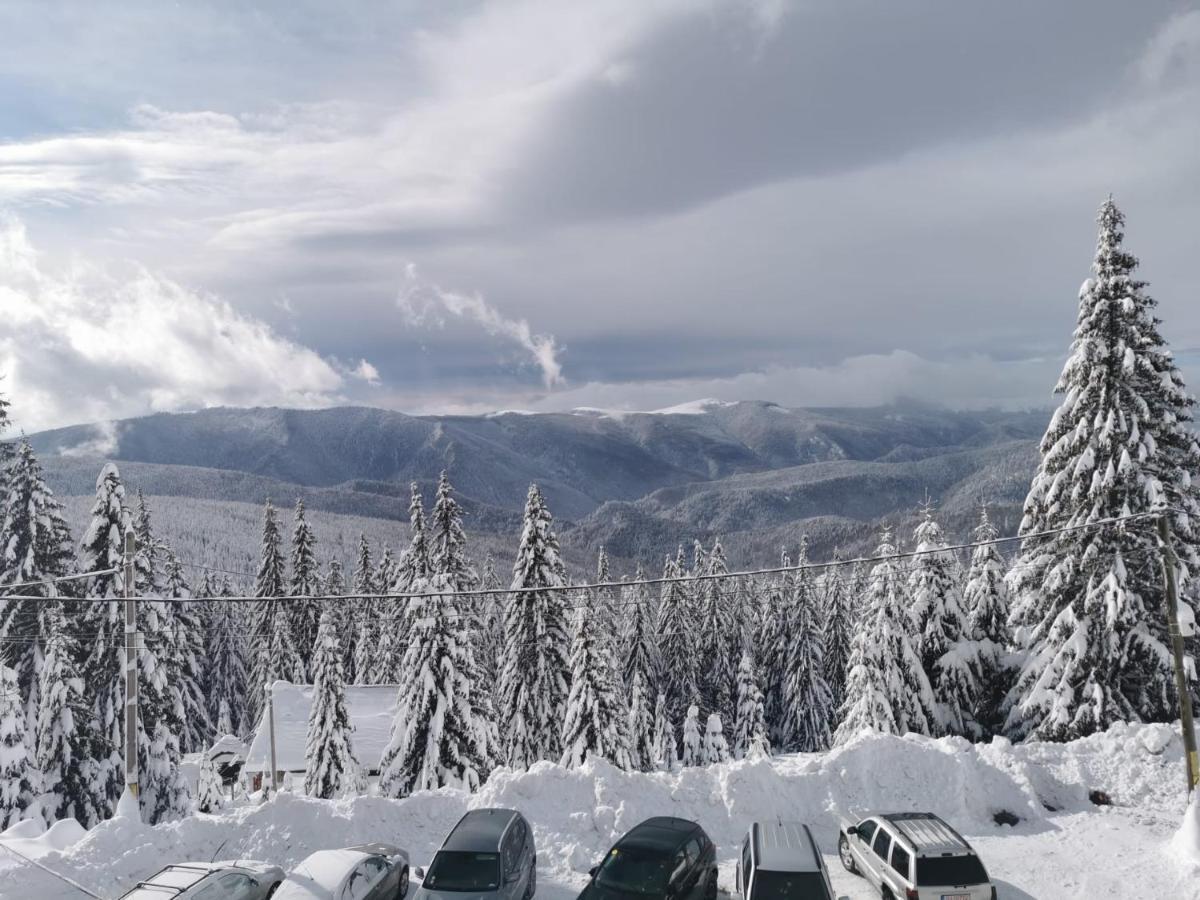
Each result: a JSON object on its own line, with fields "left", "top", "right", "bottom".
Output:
{"left": 737, "top": 821, "right": 833, "bottom": 900}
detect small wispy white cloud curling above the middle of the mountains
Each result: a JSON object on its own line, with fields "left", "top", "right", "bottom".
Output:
{"left": 396, "top": 263, "right": 564, "bottom": 388}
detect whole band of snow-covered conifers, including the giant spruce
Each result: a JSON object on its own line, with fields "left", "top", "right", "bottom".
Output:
{"left": 0, "top": 200, "right": 1200, "bottom": 828}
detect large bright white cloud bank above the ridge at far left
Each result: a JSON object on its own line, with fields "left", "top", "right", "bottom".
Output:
{"left": 0, "top": 218, "right": 348, "bottom": 438}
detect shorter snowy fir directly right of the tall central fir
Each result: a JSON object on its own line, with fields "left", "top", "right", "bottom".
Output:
{"left": 562, "top": 595, "right": 634, "bottom": 769}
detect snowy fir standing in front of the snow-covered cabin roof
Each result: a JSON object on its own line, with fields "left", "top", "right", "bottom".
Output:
{"left": 304, "top": 605, "right": 361, "bottom": 800}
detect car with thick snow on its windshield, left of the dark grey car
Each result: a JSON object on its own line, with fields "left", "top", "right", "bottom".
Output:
{"left": 271, "top": 844, "right": 408, "bottom": 900}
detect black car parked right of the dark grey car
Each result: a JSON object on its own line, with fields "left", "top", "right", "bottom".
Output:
{"left": 580, "top": 816, "right": 716, "bottom": 900}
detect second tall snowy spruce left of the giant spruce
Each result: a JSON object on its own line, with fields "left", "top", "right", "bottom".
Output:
{"left": 908, "top": 497, "right": 978, "bottom": 737}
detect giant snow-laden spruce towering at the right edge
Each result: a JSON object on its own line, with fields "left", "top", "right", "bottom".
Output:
{"left": 1007, "top": 199, "right": 1180, "bottom": 740}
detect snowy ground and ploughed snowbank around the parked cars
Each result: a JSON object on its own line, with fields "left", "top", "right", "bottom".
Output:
{"left": 0, "top": 726, "right": 1200, "bottom": 900}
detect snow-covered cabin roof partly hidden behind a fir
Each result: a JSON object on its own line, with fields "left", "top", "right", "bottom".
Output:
{"left": 245, "top": 682, "right": 400, "bottom": 772}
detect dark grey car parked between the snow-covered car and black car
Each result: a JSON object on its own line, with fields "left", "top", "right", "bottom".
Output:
{"left": 413, "top": 809, "right": 538, "bottom": 900}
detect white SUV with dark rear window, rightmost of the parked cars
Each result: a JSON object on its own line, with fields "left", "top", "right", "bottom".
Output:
{"left": 838, "top": 812, "right": 996, "bottom": 900}
